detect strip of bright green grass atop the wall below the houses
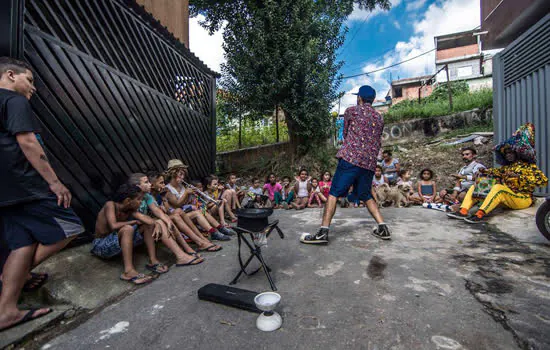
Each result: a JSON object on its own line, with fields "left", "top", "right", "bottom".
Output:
{"left": 384, "top": 86, "right": 493, "bottom": 123}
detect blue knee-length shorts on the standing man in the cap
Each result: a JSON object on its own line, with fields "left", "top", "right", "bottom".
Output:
{"left": 329, "top": 159, "right": 374, "bottom": 201}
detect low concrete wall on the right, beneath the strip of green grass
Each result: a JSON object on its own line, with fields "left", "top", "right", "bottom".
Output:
{"left": 382, "top": 109, "right": 493, "bottom": 146}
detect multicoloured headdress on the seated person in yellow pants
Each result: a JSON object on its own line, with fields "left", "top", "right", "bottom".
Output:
{"left": 494, "top": 123, "right": 537, "bottom": 165}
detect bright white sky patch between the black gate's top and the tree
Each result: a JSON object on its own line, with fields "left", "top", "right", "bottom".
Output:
{"left": 189, "top": 15, "right": 225, "bottom": 73}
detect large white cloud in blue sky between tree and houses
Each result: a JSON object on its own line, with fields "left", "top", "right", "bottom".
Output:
{"left": 341, "top": 0, "right": 486, "bottom": 112}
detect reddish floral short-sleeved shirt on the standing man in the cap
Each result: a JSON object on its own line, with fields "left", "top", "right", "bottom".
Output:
{"left": 336, "top": 104, "right": 384, "bottom": 171}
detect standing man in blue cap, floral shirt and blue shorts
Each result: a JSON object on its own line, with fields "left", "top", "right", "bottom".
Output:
{"left": 300, "top": 85, "right": 390, "bottom": 244}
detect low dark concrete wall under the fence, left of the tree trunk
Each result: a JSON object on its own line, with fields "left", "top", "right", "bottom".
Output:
{"left": 216, "top": 142, "right": 290, "bottom": 173}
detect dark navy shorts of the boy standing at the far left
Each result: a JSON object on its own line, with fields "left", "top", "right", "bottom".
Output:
{"left": 0, "top": 195, "right": 84, "bottom": 250}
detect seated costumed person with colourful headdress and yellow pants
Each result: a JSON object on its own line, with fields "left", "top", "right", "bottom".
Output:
{"left": 447, "top": 123, "right": 548, "bottom": 224}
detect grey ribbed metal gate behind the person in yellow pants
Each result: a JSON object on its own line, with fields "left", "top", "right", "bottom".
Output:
{"left": 493, "top": 14, "right": 550, "bottom": 195}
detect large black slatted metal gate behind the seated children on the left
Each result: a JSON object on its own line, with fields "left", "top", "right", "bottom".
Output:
{"left": 7, "top": 0, "right": 216, "bottom": 238}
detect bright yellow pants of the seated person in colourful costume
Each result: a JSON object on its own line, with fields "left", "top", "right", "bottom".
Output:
{"left": 460, "top": 184, "right": 533, "bottom": 214}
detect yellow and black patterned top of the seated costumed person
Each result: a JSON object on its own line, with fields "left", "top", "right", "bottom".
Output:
{"left": 485, "top": 161, "right": 548, "bottom": 195}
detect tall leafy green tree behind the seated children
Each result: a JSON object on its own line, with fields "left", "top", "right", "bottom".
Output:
{"left": 190, "top": 0, "right": 390, "bottom": 150}
